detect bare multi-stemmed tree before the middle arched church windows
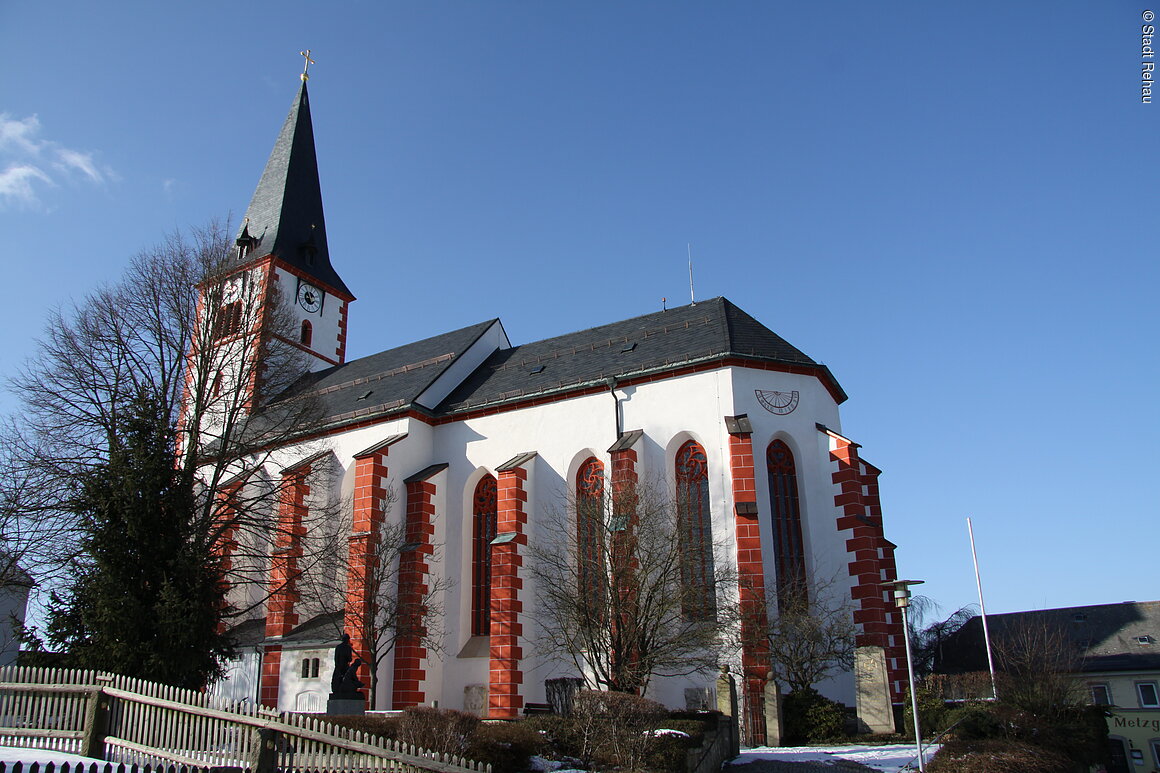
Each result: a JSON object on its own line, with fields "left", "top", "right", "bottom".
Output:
{"left": 529, "top": 475, "right": 737, "bottom": 692}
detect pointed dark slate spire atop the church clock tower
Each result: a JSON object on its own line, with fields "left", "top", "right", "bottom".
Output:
{"left": 238, "top": 80, "right": 354, "bottom": 297}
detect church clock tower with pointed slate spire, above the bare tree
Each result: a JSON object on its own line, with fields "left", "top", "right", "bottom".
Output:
{"left": 223, "top": 74, "right": 355, "bottom": 370}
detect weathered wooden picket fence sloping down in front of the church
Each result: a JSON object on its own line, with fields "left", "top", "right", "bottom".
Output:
{"left": 0, "top": 666, "right": 491, "bottom": 773}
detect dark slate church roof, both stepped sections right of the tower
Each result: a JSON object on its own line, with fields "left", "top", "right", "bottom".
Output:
{"left": 271, "top": 298, "right": 846, "bottom": 427}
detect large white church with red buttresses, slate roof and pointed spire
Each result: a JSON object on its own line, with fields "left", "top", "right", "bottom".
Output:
{"left": 204, "top": 84, "right": 906, "bottom": 741}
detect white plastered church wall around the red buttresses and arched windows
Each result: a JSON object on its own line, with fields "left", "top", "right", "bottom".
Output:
{"left": 221, "top": 368, "right": 867, "bottom": 708}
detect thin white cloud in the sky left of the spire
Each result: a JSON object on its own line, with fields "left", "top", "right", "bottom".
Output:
{"left": 0, "top": 113, "right": 116, "bottom": 208}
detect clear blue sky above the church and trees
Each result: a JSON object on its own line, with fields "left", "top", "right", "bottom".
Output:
{"left": 0, "top": 0, "right": 1160, "bottom": 612}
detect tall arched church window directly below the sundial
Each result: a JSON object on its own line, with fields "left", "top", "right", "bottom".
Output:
{"left": 766, "top": 440, "right": 807, "bottom": 612}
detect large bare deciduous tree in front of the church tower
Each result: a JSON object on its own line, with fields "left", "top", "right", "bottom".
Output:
{"left": 0, "top": 224, "right": 332, "bottom": 649}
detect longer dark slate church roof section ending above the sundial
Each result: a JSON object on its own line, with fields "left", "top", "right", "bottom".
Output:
{"left": 436, "top": 298, "right": 844, "bottom": 414}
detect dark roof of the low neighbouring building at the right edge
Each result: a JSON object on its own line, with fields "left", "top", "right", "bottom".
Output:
{"left": 936, "top": 601, "right": 1160, "bottom": 673}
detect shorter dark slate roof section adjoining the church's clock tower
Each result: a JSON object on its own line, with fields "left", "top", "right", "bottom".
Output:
{"left": 275, "top": 319, "right": 498, "bottom": 425}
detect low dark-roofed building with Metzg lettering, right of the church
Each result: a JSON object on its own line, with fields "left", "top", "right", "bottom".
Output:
{"left": 936, "top": 601, "right": 1160, "bottom": 773}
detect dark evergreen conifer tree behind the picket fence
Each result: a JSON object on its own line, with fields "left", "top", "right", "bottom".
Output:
{"left": 48, "top": 395, "right": 230, "bottom": 688}
